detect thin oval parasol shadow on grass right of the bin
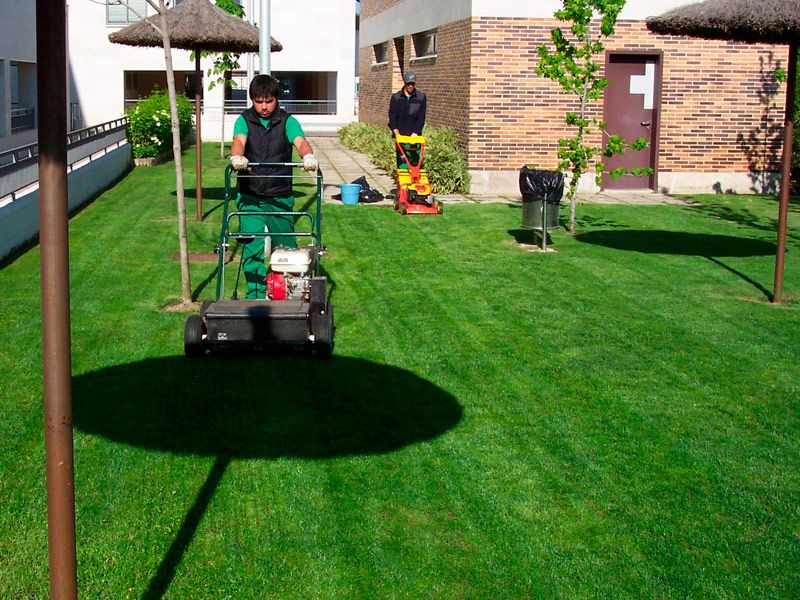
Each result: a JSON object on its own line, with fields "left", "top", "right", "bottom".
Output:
{"left": 575, "top": 230, "right": 777, "bottom": 302}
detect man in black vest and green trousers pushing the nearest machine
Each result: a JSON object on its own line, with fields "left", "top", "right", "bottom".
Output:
{"left": 231, "top": 75, "right": 319, "bottom": 299}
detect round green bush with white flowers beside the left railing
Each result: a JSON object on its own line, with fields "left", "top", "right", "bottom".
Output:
{"left": 125, "top": 90, "right": 192, "bottom": 158}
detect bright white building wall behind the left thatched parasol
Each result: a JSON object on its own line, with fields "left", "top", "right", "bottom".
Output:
{"left": 65, "top": 0, "right": 355, "bottom": 134}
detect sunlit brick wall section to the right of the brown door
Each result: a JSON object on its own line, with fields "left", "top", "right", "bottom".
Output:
{"left": 607, "top": 21, "right": 789, "bottom": 173}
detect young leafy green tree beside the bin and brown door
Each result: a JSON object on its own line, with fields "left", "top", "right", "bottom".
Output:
{"left": 536, "top": 0, "right": 652, "bottom": 234}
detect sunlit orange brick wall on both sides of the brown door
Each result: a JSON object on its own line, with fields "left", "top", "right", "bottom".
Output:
{"left": 467, "top": 19, "right": 788, "bottom": 172}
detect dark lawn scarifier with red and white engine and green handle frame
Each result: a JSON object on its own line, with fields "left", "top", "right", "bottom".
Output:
{"left": 184, "top": 162, "right": 334, "bottom": 358}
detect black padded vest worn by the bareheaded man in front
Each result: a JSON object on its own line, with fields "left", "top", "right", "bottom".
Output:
{"left": 238, "top": 106, "right": 292, "bottom": 196}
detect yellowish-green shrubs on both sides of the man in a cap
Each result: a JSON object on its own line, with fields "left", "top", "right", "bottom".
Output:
{"left": 339, "top": 123, "right": 470, "bottom": 194}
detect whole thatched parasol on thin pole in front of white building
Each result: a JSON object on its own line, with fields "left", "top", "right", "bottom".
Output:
{"left": 108, "top": 0, "right": 283, "bottom": 221}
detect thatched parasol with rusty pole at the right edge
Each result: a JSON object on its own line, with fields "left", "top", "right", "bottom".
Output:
{"left": 647, "top": 0, "right": 800, "bottom": 302}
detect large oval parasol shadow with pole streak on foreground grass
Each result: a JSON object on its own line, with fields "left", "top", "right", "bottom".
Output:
{"left": 72, "top": 355, "right": 463, "bottom": 598}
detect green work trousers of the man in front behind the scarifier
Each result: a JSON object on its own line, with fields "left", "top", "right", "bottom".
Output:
{"left": 241, "top": 194, "right": 297, "bottom": 299}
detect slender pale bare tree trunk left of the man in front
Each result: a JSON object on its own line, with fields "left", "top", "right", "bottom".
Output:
{"left": 158, "top": 0, "right": 192, "bottom": 304}
